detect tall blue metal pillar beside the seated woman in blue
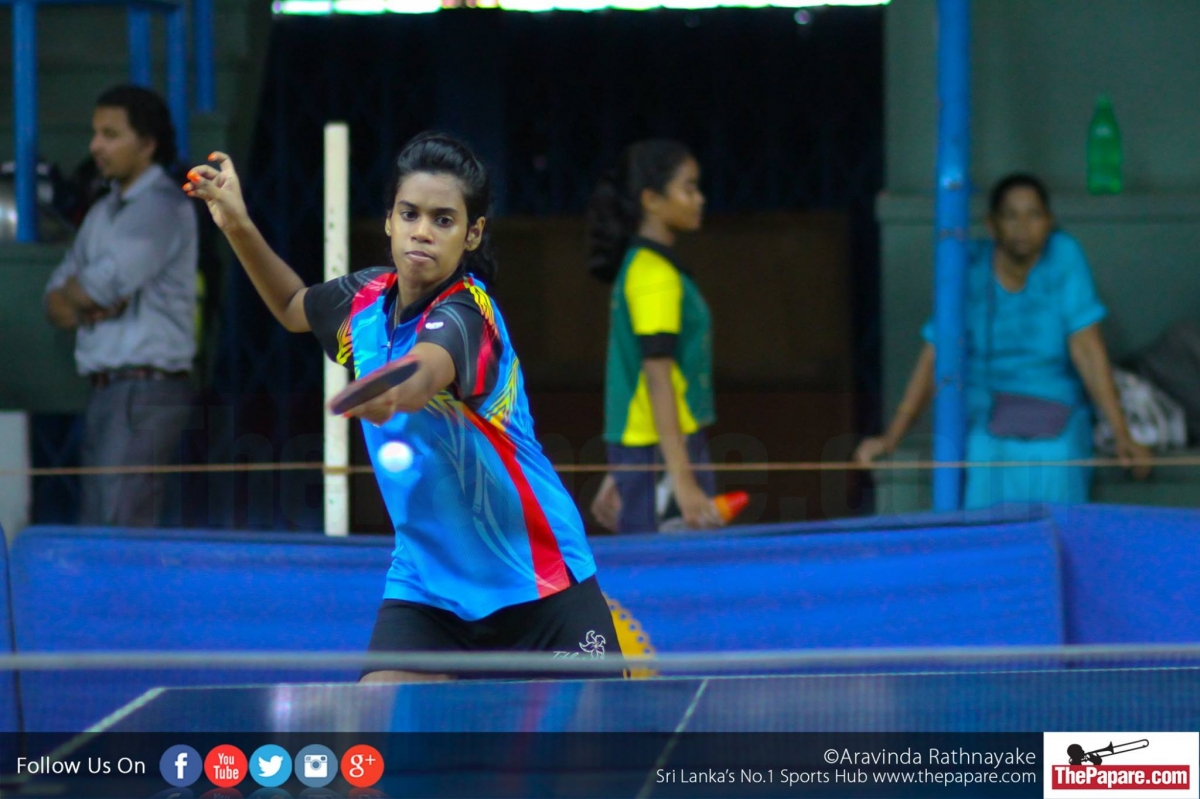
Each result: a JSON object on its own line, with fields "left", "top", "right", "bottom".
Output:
{"left": 934, "top": 0, "right": 971, "bottom": 510}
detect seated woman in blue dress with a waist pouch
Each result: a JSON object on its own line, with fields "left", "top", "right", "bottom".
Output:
{"left": 856, "top": 174, "right": 1150, "bottom": 507}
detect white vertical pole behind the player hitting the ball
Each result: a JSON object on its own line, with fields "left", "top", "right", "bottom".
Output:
{"left": 324, "top": 122, "right": 350, "bottom": 535}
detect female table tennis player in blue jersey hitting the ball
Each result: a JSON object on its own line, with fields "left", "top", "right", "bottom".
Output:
{"left": 184, "top": 133, "right": 620, "bottom": 681}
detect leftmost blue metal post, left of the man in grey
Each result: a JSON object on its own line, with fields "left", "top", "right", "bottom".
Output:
{"left": 12, "top": 0, "right": 37, "bottom": 241}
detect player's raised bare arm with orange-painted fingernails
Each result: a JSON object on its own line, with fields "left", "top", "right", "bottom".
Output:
{"left": 184, "top": 152, "right": 312, "bottom": 332}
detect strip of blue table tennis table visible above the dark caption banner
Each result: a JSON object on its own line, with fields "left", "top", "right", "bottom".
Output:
{"left": 92, "top": 667, "right": 1200, "bottom": 733}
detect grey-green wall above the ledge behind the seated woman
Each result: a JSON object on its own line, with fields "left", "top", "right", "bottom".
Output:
{"left": 884, "top": 0, "right": 1200, "bottom": 193}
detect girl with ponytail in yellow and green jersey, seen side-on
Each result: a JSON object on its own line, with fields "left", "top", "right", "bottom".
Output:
{"left": 588, "top": 139, "right": 722, "bottom": 533}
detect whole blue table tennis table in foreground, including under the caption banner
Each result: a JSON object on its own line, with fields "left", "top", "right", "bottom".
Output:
{"left": 12, "top": 666, "right": 1200, "bottom": 799}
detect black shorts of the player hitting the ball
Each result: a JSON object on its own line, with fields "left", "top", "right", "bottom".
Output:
{"left": 367, "top": 576, "right": 623, "bottom": 675}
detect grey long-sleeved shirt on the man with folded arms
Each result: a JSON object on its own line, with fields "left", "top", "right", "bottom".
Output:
{"left": 46, "top": 164, "right": 198, "bottom": 374}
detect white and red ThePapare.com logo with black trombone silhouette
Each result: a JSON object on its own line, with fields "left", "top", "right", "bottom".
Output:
{"left": 1042, "top": 732, "right": 1200, "bottom": 799}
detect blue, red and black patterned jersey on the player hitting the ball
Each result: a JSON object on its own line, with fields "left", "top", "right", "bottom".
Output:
{"left": 305, "top": 268, "right": 595, "bottom": 620}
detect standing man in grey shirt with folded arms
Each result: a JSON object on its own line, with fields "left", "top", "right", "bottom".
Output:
{"left": 44, "top": 86, "right": 198, "bottom": 527}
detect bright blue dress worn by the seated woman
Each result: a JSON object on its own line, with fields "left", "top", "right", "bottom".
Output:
{"left": 922, "top": 232, "right": 1108, "bottom": 507}
